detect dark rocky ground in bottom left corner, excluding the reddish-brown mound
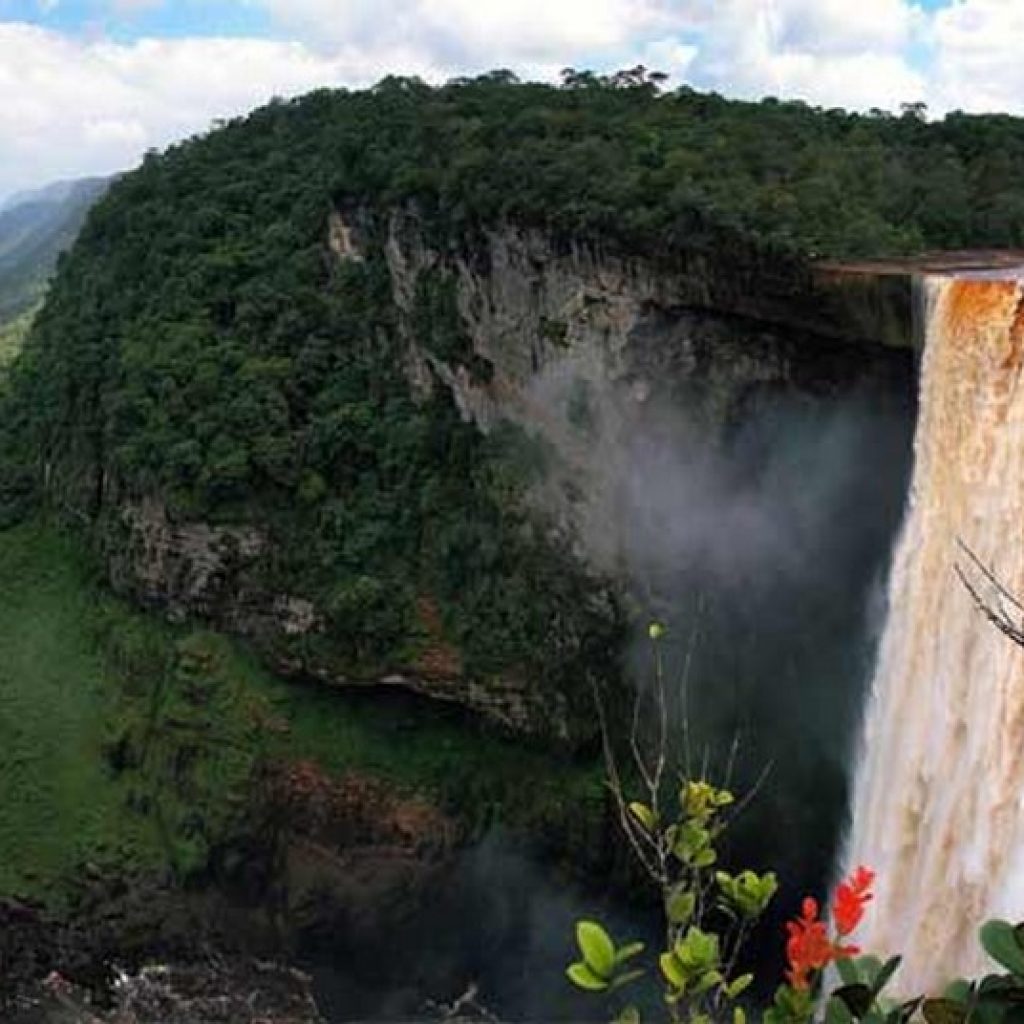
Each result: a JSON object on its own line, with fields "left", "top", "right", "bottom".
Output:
{"left": 0, "top": 883, "right": 323, "bottom": 1024}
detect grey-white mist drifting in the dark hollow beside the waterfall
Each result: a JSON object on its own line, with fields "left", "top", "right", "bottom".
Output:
{"left": 532, "top": 335, "right": 915, "bottom": 908}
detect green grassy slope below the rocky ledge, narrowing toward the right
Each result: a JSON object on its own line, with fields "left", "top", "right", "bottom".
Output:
{"left": 0, "top": 524, "right": 601, "bottom": 898}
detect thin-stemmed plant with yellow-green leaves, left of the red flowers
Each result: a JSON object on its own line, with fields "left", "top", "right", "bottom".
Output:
{"left": 566, "top": 623, "right": 778, "bottom": 1024}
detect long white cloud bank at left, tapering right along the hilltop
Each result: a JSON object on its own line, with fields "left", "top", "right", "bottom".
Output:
{"left": 0, "top": 23, "right": 440, "bottom": 196}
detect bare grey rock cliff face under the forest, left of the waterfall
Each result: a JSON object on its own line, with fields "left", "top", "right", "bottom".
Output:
{"left": 374, "top": 210, "right": 913, "bottom": 572}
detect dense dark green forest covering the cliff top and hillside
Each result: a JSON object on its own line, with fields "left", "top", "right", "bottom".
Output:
{"left": 6, "top": 71, "right": 1024, "bottom": 720}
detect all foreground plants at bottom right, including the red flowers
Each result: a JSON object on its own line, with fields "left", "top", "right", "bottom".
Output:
{"left": 566, "top": 624, "right": 1024, "bottom": 1024}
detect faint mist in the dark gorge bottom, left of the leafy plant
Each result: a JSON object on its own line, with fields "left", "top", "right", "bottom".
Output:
{"left": 312, "top": 828, "right": 654, "bottom": 1024}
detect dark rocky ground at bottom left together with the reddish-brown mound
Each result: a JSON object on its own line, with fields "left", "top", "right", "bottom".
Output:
{"left": 0, "top": 764, "right": 472, "bottom": 1024}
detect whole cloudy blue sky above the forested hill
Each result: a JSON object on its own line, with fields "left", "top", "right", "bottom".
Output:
{"left": 0, "top": 0, "right": 1024, "bottom": 198}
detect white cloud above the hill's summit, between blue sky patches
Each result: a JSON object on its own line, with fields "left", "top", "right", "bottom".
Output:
{"left": 256, "top": 0, "right": 927, "bottom": 109}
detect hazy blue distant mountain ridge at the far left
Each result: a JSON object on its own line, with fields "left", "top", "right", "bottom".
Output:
{"left": 0, "top": 177, "right": 113, "bottom": 327}
